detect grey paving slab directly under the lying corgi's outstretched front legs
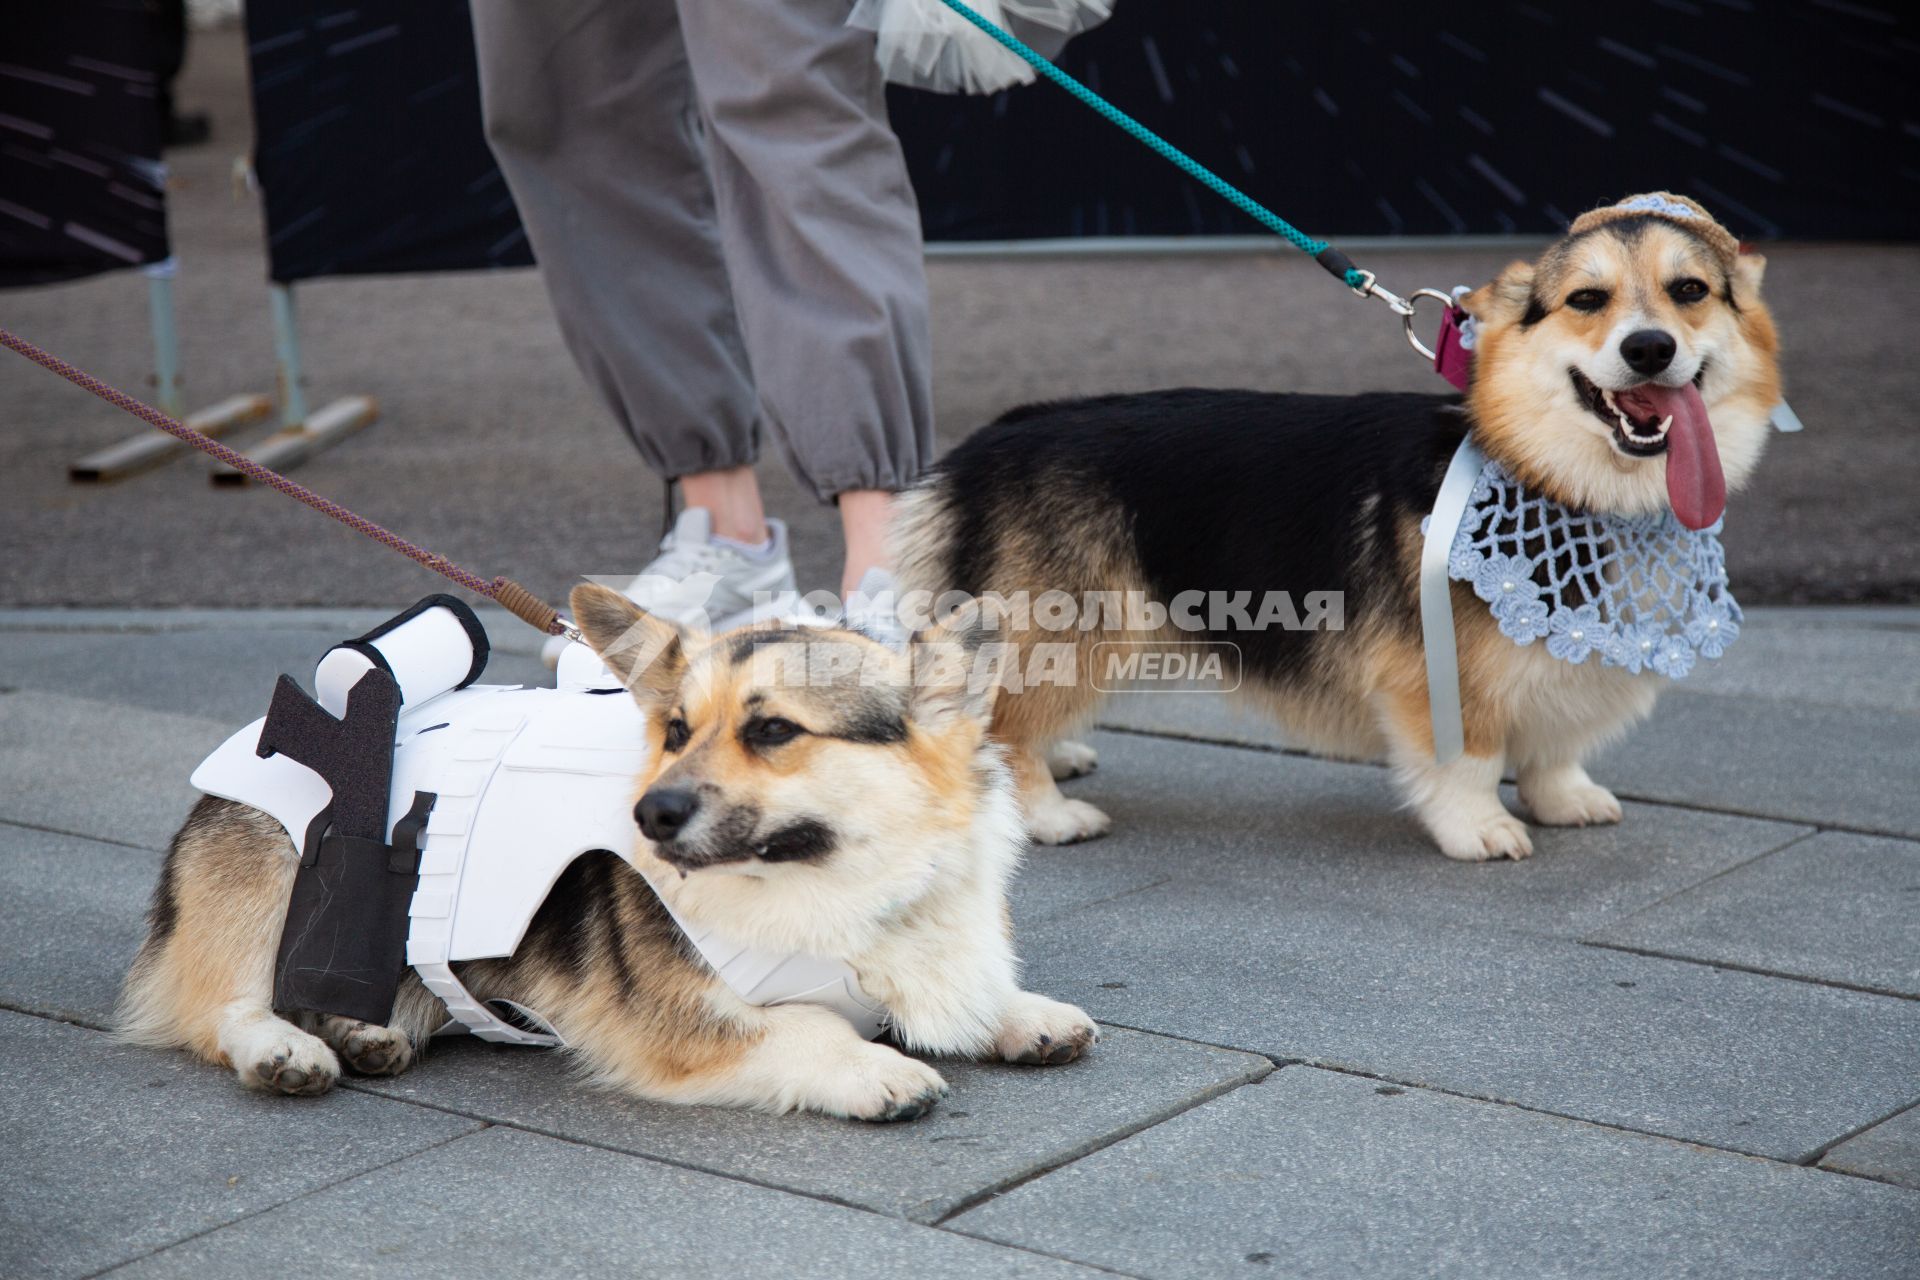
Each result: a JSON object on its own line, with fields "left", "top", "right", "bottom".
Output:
{"left": 359, "top": 1031, "right": 1271, "bottom": 1221}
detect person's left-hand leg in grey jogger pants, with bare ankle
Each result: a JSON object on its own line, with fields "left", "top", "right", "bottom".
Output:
{"left": 472, "top": 0, "right": 766, "bottom": 506}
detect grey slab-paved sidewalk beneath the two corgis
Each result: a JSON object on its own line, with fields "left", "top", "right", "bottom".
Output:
{"left": 0, "top": 606, "right": 1920, "bottom": 1280}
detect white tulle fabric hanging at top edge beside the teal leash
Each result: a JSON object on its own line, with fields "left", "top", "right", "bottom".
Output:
{"left": 847, "top": 0, "right": 1114, "bottom": 94}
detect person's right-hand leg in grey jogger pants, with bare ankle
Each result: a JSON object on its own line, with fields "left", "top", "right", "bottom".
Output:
{"left": 680, "top": 0, "right": 933, "bottom": 589}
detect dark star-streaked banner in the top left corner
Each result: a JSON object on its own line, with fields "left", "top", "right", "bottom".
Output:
{"left": 0, "top": 0, "right": 167, "bottom": 288}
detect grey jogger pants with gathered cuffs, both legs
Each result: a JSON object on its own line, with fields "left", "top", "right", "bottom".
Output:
{"left": 472, "top": 0, "right": 933, "bottom": 499}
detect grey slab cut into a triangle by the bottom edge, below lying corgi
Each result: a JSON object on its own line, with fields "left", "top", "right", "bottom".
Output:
{"left": 115, "top": 1128, "right": 1100, "bottom": 1280}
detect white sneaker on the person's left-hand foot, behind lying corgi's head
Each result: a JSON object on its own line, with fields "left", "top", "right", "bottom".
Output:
{"left": 540, "top": 507, "right": 801, "bottom": 668}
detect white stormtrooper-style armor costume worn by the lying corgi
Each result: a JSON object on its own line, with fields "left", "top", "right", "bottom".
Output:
{"left": 192, "top": 597, "right": 885, "bottom": 1046}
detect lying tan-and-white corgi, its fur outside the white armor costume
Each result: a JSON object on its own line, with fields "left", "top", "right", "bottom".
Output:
{"left": 119, "top": 585, "right": 1096, "bottom": 1121}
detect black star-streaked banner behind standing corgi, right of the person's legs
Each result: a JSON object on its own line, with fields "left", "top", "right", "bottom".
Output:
{"left": 895, "top": 0, "right": 1920, "bottom": 240}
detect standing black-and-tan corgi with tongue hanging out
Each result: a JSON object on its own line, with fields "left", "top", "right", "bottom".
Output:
{"left": 897, "top": 192, "right": 1780, "bottom": 860}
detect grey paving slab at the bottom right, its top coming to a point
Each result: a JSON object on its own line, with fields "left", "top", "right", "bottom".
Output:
{"left": 950, "top": 1067, "right": 1920, "bottom": 1280}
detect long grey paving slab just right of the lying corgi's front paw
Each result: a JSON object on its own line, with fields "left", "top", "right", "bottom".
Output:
{"left": 1025, "top": 879, "right": 1920, "bottom": 1159}
